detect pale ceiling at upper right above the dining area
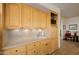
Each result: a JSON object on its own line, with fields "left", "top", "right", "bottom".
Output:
{"left": 52, "top": 3, "right": 79, "bottom": 17}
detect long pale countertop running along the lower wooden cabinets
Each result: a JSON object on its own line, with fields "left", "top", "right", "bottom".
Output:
{"left": 3, "top": 38, "right": 48, "bottom": 49}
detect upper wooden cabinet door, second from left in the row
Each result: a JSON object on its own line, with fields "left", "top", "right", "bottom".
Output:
{"left": 21, "top": 4, "right": 32, "bottom": 28}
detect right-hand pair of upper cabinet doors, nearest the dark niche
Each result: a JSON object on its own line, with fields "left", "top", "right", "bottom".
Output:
{"left": 32, "top": 9, "right": 47, "bottom": 28}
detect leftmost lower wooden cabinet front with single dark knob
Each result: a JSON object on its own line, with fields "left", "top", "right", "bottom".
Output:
{"left": 4, "top": 46, "right": 26, "bottom": 55}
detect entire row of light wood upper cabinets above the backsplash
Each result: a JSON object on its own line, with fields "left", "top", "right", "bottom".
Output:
{"left": 5, "top": 4, "right": 50, "bottom": 29}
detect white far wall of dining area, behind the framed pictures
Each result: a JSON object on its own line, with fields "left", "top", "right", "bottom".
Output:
{"left": 61, "top": 16, "right": 79, "bottom": 37}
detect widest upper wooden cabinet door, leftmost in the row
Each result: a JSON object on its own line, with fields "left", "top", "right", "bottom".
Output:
{"left": 5, "top": 4, "right": 21, "bottom": 29}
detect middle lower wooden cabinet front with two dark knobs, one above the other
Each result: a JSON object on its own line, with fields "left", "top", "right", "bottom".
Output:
{"left": 26, "top": 42, "right": 39, "bottom": 55}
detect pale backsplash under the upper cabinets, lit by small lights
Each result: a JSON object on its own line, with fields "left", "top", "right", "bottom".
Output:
{"left": 5, "top": 29, "right": 49, "bottom": 45}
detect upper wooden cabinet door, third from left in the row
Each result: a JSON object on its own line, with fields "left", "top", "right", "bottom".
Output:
{"left": 32, "top": 8, "right": 40, "bottom": 28}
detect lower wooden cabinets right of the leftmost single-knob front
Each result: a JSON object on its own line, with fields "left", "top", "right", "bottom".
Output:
{"left": 26, "top": 40, "right": 50, "bottom": 55}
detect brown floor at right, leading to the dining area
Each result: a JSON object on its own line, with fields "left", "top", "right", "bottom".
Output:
{"left": 53, "top": 40, "right": 79, "bottom": 55}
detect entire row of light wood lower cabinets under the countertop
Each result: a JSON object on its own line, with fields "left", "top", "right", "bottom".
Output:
{"left": 4, "top": 39, "right": 51, "bottom": 55}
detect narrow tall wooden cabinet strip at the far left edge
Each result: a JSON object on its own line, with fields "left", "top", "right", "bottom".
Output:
{"left": 0, "top": 3, "right": 4, "bottom": 51}
